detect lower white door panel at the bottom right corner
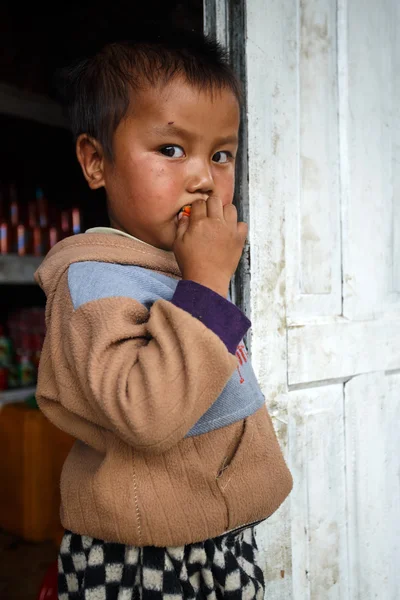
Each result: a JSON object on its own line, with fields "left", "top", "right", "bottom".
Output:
{"left": 345, "top": 373, "right": 400, "bottom": 600}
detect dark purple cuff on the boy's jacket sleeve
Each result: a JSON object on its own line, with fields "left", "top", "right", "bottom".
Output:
{"left": 171, "top": 280, "right": 251, "bottom": 354}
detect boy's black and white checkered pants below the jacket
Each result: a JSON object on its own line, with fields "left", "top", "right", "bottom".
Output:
{"left": 58, "top": 528, "right": 264, "bottom": 600}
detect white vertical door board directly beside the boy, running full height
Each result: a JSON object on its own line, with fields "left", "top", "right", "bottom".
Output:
{"left": 246, "top": 0, "right": 297, "bottom": 600}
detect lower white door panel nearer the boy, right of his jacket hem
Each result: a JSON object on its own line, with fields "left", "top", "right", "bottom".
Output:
{"left": 288, "top": 384, "right": 348, "bottom": 600}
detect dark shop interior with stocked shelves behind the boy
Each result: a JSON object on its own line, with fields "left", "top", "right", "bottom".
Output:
{"left": 0, "top": 0, "right": 203, "bottom": 600}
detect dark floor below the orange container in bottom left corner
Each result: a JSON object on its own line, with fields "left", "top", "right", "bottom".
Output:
{"left": 0, "top": 530, "right": 58, "bottom": 600}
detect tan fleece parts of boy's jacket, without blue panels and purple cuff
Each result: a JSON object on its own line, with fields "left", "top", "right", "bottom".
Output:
{"left": 36, "top": 234, "right": 292, "bottom": 546}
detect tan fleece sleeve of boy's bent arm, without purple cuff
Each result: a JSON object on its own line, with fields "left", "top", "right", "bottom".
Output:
{"left": 60, "top": 278, "right": 248, "bottom": 453}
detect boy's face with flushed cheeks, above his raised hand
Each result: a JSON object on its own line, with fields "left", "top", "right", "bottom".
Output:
{"left": 103, "top": 79, "right": 239, "bottom": 250}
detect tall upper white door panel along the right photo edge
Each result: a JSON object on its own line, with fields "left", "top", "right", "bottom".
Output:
{"left": 342, "top": 0, "right": 400, "bottom": 318}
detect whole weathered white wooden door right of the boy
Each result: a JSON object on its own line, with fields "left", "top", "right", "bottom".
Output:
{"left": 206, "top": 0, "right": 400, "bottom": 600}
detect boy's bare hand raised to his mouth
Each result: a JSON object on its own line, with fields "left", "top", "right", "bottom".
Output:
{"left": 173, "top": 196, "right": 247, "bottom": 297}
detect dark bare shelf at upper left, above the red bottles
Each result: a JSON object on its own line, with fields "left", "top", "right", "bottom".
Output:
{"left": 0, "top": 82, "right": 68, "bottom": 129}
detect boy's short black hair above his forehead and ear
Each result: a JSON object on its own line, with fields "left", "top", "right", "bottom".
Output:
{"left": 57, "top": 27, "right": 241, "bottom": 160}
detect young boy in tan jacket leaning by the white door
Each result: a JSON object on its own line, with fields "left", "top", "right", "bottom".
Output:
{"left": 36, "top": 28, "right": 292, "bottom": 600}
